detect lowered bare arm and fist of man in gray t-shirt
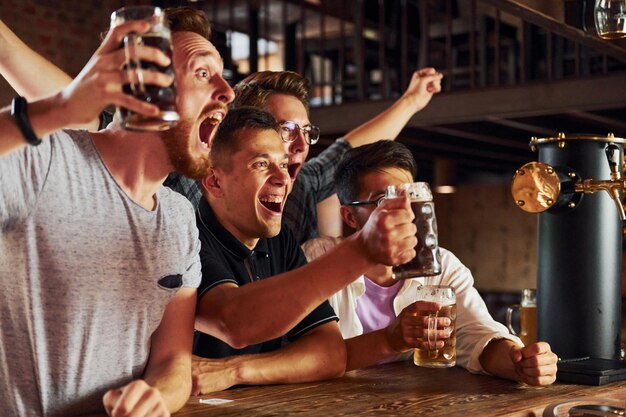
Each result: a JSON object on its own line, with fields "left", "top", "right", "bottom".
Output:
{"left": 103, "top": 288, "right": 196, "bottom": 417}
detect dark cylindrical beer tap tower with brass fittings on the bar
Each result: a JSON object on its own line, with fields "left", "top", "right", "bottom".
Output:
{"left": 511, "top": 133, "right": 626, "bottom": 382}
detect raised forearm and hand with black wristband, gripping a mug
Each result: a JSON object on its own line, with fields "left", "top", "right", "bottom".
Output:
{"left": 0, "top": 21, "right": 168, "bottom": 156}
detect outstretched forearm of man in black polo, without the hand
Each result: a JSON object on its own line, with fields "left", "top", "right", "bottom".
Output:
{"left": 196, "top": 232, "right": 371, "bottom": 348}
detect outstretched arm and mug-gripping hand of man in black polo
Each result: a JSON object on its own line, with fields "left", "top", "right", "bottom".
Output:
{"left": 196, "top": 199, "right": 416, "bottom": 348}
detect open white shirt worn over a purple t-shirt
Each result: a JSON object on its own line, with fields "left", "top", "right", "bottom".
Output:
{"left": 329, "top": 248, "right": 524, "bottom": 373}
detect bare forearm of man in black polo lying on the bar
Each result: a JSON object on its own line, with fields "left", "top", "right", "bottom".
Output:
{"left": 193, "top": 322, "right": 346, "bottom": 395}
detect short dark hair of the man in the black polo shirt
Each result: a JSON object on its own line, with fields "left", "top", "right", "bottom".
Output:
{"left": 209, "top": 106, "right": 278, "bottom": 172}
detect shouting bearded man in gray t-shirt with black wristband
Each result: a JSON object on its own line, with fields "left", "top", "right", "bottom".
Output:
{"left": 0, "top": 8, "right": 233, "bottom": 417}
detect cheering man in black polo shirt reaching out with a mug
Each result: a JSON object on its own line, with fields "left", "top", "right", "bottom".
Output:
{"left": 193, "top": 107, "right": 416, "bottom": 393}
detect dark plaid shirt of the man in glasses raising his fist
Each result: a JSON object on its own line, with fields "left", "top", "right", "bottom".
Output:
{"left": 163, "top": 138, "right": 352, "bottom": 244}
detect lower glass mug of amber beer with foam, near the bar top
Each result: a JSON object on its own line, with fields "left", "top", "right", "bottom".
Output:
{"left": 413, "top": 285, "right": 456, "bottom": 368}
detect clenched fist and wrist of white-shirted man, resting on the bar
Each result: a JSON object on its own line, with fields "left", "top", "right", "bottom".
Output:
{"left": 480, "top": 339, "right": 558, "bottom": 385}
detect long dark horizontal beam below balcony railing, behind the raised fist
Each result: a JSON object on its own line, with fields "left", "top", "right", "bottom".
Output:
{"left": 311, "top": 73, "right": 626, "bottom": 135}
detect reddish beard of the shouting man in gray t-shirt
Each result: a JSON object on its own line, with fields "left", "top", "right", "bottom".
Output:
{"left": 161, "top": 120, "right": 210, "bottom": 180}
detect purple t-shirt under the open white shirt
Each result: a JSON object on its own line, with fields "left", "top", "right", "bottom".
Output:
{"left": 356, "top": 277, "right": 402, "bottom": 333}
